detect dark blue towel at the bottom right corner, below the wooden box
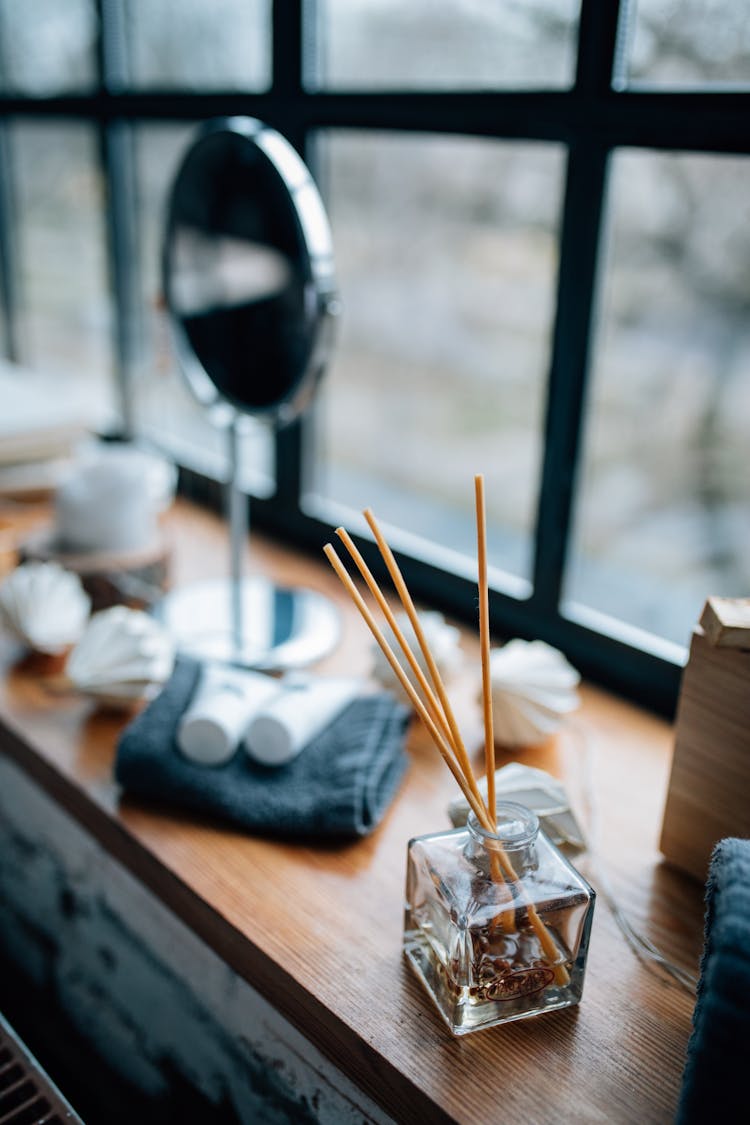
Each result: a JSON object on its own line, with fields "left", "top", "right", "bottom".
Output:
{"left": 677, "top": 839, "right": 750, "bottom": 1125}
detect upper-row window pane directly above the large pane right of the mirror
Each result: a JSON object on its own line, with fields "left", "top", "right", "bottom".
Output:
{"left": 311, "top": 0, "right": 580, "bottom": 89}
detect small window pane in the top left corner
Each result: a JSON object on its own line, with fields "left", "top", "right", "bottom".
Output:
{"left": 0, "top": 0, "right": 98, "bottom": 96}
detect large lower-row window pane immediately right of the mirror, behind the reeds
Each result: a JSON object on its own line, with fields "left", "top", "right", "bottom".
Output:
{"left": 316, "top": 133, "right": 563, "bottom": 576}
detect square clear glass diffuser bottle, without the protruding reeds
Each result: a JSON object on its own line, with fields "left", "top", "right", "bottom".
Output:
{"left": 404, "top": 801, "right": 595, "bottom": 1035}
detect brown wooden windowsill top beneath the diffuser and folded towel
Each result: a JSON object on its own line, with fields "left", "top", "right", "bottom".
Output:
{"left": 0, "top": 505, "right": 702, "bottom": 1125}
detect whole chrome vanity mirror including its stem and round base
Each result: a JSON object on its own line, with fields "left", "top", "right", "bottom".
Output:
{"left": 160, "top": 117, "right": 338, "bottom": 668}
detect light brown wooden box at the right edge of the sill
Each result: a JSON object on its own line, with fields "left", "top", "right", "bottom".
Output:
{"left": 660, "top": 599, "right": 750, "bottom": 881}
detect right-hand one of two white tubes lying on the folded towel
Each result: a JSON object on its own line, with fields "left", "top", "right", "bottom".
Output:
{"left": 244, "top": 678, "right": 362, "bottom": 766}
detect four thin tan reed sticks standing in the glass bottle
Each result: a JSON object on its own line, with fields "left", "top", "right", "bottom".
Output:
{"left": 324, "top": 474, "right": 569, "bottom": 984}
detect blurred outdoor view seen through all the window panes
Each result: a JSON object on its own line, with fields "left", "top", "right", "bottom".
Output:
{"left": 0, "top": 0, "right": 750, "bottom": 644}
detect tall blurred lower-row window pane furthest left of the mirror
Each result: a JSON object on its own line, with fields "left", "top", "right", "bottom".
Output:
{"left": 11, "top": 122, "right": 114, "bottom": 423}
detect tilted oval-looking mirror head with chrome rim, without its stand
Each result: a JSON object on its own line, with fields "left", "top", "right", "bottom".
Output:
{"left": 163, "top": 117, "right": 336, "bottom": 423}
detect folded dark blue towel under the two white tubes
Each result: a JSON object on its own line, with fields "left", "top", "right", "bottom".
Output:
{"left": 115, "top": 657, "right": 408, "bottom": 837}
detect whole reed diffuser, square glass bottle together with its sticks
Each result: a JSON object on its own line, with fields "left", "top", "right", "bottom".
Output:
{"left": 324, "top": 474, "right": 595, "bottom": 1035}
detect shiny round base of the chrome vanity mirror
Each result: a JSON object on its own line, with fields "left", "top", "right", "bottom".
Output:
{"left": 154, "top": 577, "right": 340, "bottom": 672}
